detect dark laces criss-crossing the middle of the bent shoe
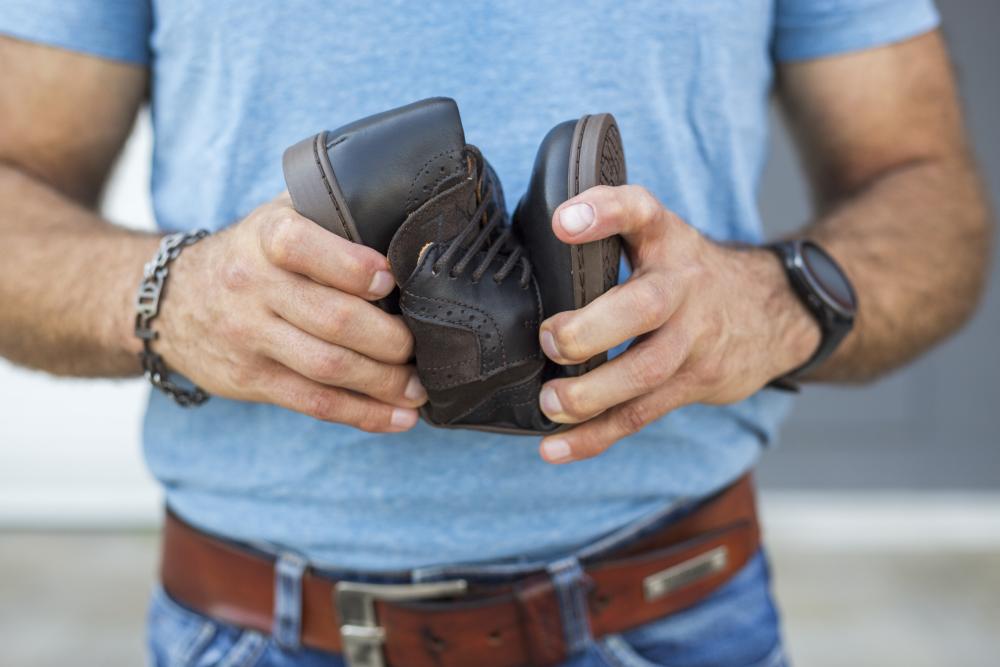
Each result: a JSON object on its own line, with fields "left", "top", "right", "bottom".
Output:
{"left": 431, "top": 146, "right": 531, "bottom": 289}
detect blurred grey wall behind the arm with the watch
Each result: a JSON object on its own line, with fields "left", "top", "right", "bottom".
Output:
{"left": 760, "top": 0, "right": 1000, "bottom": 489}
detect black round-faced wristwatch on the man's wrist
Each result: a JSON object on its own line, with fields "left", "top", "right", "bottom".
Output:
{"left": 766, "top": 239, "right": 858, "bottom": 390}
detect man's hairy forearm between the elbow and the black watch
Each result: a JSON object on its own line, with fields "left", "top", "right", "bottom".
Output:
{"left": 804, "top": 156, "right": 992, "bottom": 382}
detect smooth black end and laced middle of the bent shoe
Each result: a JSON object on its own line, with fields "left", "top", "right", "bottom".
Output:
{"left": 284, "top": 98, "right": 547, "bottom": 433}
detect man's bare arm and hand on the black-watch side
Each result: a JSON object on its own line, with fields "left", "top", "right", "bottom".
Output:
{"left": 540, "top": 32, "right": 991, "bottom": 462}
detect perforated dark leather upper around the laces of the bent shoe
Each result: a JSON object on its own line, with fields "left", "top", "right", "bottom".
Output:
{"left": 389, "top": 172, "right": 544, "bottom": 430}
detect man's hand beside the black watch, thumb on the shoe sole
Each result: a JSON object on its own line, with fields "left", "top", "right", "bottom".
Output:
{"left": 539, "top": 186, "right": 820, "bottom": 463}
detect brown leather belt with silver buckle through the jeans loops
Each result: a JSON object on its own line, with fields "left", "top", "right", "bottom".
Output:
{"left": 161, "top": 476, "right": 759, "bottom": 667}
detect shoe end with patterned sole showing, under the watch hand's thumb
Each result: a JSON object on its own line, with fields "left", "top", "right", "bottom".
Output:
{"left": 513, "top": 113, "right": 626, "bottom": 380}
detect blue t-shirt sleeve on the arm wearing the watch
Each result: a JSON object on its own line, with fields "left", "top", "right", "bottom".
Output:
{"left": 773, "top": 0, "right": 940, "bottom": 61}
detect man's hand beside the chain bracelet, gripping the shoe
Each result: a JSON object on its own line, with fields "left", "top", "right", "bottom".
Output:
{"left": 153, "top": 193, "right": 427, "bottom": 432}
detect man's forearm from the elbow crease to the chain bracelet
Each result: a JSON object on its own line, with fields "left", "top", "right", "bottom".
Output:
{"left": 0, "top": 165, "right": 157, "bottom": 377}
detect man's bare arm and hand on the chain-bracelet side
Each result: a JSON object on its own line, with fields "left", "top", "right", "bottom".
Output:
{"left": 0, "top": 37, "right": 426, "bottom": 431}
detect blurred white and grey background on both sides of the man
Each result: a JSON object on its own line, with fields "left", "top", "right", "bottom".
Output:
{"left": 0, "top": 0, "right": 1000, "bottom": 667}
